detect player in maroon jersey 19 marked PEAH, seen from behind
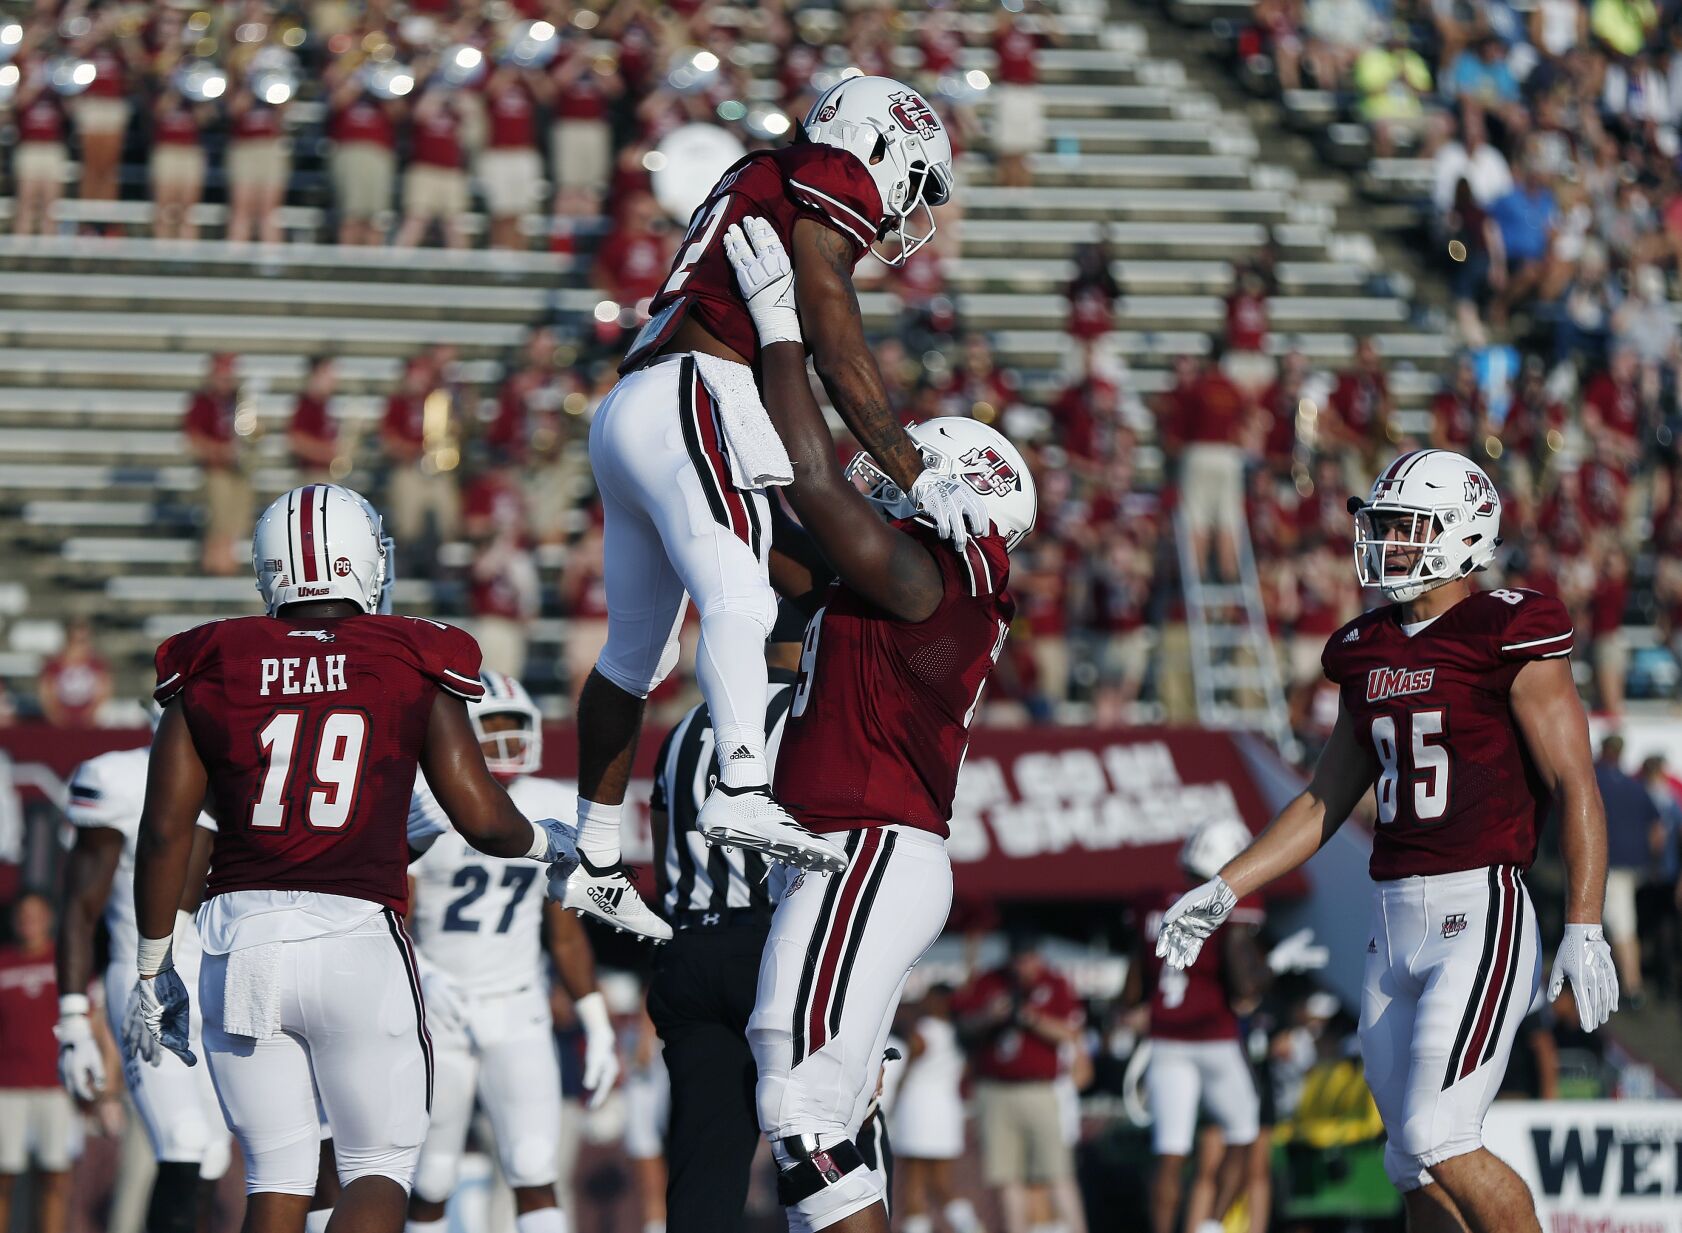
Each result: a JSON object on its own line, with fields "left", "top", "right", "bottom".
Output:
{"left": 130, "top": 484, "right": 575, "bottom": 1233}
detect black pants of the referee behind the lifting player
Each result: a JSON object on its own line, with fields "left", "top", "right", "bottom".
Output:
{"left": 648, "top": 922, "right": 770, "bottom": 1233}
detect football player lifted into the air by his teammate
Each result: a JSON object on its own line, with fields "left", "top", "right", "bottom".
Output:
{"left": 567, "top": 77, "right": 987, "bottom": 939}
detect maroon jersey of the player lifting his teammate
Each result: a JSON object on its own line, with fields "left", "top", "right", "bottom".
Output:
{"left": 775, "top": 523, "right": 1016, "bottom": 838}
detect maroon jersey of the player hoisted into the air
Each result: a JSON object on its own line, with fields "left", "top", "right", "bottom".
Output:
{"left": 619, "top": 141, "right": 881, "bottom": 372}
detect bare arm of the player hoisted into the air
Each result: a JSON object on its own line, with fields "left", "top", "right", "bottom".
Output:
{"left": 793, "top": 219, "right": 923, "bottom": 491}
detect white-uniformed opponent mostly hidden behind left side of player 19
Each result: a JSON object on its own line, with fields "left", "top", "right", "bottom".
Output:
{"left": 56, "top": 730, "right": 232, "bottom": 1233}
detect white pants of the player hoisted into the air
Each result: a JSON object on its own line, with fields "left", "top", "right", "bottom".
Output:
{"left": 590, "top": 355, "right": 777, "bottom": 787}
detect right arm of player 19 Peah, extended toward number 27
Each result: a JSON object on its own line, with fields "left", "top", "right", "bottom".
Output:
{"left": 421, "top": 693, "right": 572, "bottom": 861}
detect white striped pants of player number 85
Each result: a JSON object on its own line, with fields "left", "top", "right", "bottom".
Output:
{"left": 1361, "top": 866, "right": 1542, "bottom": 1191}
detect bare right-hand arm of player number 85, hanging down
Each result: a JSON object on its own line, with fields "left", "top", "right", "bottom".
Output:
{"left": 1510, "top": 659, "right": 1606, "bottom": 925}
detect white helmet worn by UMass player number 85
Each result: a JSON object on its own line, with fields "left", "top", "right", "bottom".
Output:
{"left": 1349, "top": 449, "right": 1500, "bottom": 604}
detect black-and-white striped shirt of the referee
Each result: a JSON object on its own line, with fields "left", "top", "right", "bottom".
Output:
{"left": 653, "top": 668, "right": 794, "bottom": 920}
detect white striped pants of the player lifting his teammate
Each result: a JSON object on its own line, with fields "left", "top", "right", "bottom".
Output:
{"left": 747, "top": 826, "right": 952, "bottom": 1230}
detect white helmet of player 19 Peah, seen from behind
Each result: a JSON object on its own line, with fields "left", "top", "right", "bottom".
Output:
{"left": 251, "top": 484, "right": 385, "bottom": 616}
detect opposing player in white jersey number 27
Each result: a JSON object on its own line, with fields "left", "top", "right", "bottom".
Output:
{"left": 407, "top": 673, "right": 619, "bottom": 1233}
